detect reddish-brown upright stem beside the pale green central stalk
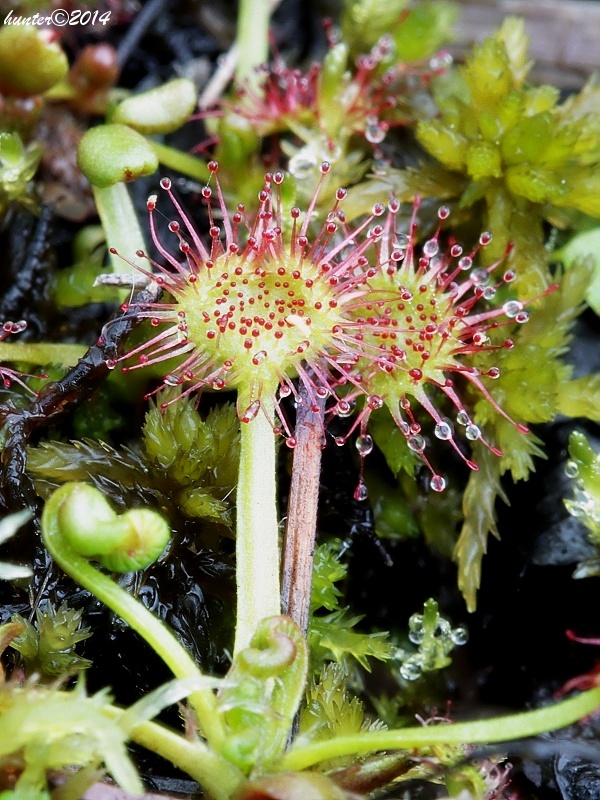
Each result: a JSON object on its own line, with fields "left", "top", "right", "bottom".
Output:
{"left": 281, "top": 386, "right": 325, "bottom": 634}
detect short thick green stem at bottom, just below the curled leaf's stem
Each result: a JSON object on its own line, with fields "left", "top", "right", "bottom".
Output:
{"left": 105, "top": 706, "right": 244, "bottom": 800}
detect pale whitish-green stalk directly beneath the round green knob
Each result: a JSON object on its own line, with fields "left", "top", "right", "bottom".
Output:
{"left": 92, "top": 183, "right": 148, "bottom": 276}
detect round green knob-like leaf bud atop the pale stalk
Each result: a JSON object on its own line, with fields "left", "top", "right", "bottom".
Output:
{"left": 77, "top": 125, "right": 158, "bottom": 188}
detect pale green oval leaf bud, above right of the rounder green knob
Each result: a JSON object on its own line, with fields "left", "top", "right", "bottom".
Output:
{"left": 111, "top": 78, "right": 197, "bottom": 136}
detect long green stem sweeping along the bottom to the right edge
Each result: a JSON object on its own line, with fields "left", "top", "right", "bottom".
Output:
{"left": 278, "top": 688, "right": 600, "bottom": 770}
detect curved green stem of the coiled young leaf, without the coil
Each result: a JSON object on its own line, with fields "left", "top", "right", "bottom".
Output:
{"left": 42, "top": 483, "right": 225, "bottom": 750}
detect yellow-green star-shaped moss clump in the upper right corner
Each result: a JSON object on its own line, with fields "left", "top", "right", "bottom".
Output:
{"left": 417, "top": 18, "right": 600, "bottom": 297}
